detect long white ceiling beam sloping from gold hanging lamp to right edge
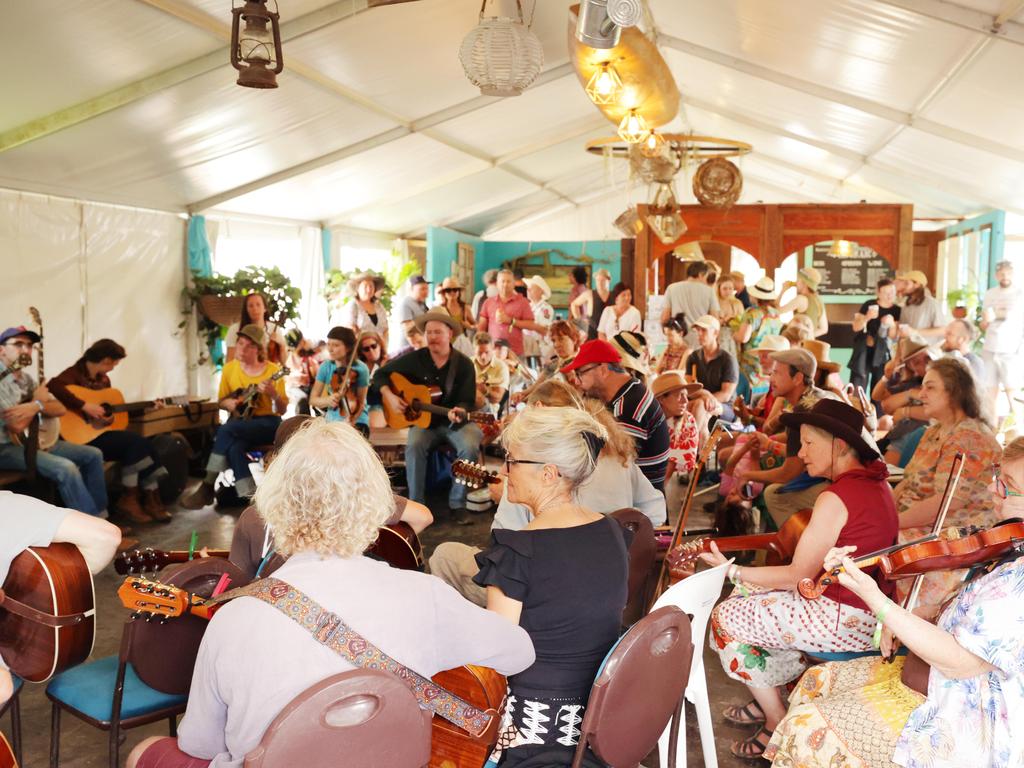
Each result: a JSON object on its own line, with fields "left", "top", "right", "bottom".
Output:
{"left": 657, "top": 35, "right": 1024, "bottom": 163}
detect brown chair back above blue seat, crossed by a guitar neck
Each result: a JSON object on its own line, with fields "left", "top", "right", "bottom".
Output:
{"left": 122, "top": 557, "right": 251, "bottom": 693}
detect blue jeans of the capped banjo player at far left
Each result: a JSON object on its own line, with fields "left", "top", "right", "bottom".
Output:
{"left": 0, "top": 440, "right": 106, "bottom": 515}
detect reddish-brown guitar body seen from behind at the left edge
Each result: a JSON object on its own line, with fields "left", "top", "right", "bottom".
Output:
{"left": 0, "top": 544, "right": 96, "bottom": 683}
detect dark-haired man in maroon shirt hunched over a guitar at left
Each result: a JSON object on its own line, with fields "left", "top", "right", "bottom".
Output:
{"left": 50, "top": 339, "right": 171, "bottom": 522}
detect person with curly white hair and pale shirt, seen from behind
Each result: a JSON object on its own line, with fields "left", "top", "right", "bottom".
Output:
{"left": 128, "top": 419, "right": 534, "bottom": 768}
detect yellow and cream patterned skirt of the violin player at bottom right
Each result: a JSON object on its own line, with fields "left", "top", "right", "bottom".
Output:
{"left": 764, "top": 656, "right": 925, "bottom": 768}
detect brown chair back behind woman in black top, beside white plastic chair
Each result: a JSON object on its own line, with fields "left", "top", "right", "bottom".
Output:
{"left": 572, "top": 606, "right": 693, "bottom": 768}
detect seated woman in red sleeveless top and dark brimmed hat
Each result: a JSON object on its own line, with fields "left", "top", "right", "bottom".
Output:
{"left": 701, "top": 399, "right": 899, "bottom": 758}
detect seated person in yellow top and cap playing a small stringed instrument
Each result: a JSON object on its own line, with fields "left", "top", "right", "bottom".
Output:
{"left": 181, "top": 325, "right": 288, "bottom": 509}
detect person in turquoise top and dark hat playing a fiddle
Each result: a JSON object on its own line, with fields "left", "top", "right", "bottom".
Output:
{"left": 309, "top": 326, "right": 370, "bottom": 437}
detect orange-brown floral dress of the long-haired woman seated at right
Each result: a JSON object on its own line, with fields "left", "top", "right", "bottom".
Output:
{"left": 894, "top": 419, "right": 1001, "bottom": 605}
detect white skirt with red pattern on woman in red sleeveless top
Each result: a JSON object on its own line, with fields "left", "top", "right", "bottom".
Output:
{"left": 710, "top": 586, "right": 876, "bottom": 688}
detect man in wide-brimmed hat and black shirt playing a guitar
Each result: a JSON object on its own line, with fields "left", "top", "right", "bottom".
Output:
{"left": 371, "top": 309, "right": 483, "bottom": 525}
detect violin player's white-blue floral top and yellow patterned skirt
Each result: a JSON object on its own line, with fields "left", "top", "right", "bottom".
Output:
{"left": 765, "top": 558, "right": 1024, "bottom": 768}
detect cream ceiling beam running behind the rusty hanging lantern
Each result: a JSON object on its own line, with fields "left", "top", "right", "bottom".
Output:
{"left": 0, "top": 0, "right": 367, "bottom": 153}
